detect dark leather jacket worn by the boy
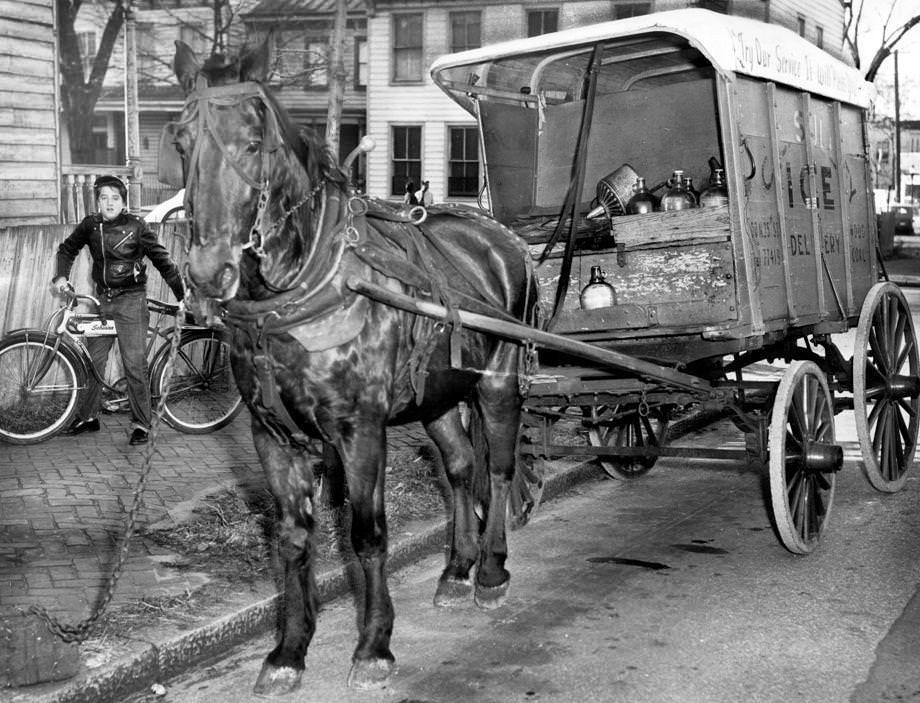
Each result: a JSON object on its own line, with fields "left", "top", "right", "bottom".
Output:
{"left": 54, "top": 212, "right": 182, "bottom": 300}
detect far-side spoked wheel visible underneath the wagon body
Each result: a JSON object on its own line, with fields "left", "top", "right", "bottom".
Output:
{"left": 588, "top": 406, "right": 668, "bottom": 479}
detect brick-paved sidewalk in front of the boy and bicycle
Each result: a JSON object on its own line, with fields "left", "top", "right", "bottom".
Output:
{"left": 0, "top": 412, "right": 428, "bottom": 623}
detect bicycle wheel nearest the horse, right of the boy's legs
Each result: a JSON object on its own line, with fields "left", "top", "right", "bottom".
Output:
{"left": 151, "top": 330, "right": 243, "bottom": 434}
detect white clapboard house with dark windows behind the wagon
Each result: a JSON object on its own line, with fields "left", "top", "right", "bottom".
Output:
{"left": 367, "top": 0, "right": 843, "bottom": 202}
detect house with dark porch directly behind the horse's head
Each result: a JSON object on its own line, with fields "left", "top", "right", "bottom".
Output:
{"left": 87, "top": 0, "right": 366, "bottom": 207}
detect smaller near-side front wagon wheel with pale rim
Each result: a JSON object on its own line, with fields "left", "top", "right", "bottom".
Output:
{"left": 769, "top": 361, "right": 843, "bottom": 554}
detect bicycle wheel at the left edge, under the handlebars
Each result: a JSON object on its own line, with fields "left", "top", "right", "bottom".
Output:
{"left": 0, "top": 331, "right": 85, "bottom": 444}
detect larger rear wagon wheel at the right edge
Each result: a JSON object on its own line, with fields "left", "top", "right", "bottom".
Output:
{"left": 853, "top": 282, "right": 920, "bottom": 493}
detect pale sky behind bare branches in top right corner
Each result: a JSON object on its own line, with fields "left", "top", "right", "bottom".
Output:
{"left": 859, "top": 0, "right": 920, "bottom": 120}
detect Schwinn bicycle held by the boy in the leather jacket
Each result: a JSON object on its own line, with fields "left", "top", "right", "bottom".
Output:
{"left": 0, "top": 291, "right": 242, "bottom": 444}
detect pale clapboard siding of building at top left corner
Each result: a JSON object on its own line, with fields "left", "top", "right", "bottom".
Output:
{"left": 0, "top": 0, "right": 60, "bottom": 227}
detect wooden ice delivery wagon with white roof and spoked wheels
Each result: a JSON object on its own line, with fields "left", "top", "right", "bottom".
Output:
{"left": 431, "top": 9, "right": 920, "bottom": 553}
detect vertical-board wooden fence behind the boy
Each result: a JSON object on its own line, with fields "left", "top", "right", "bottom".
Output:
{"left": 0, "top": 220, "right": 188, "bottom": 333}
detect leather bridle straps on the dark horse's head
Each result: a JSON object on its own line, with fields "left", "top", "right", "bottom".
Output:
{"left": 176, "top": 76, "right": 326, "bottom": 286}
